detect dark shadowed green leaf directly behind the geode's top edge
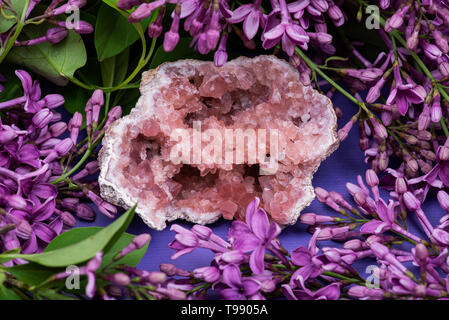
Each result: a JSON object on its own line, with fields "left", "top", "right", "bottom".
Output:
{"left": 150, "top": 38, "right": 213, "bottom": 69}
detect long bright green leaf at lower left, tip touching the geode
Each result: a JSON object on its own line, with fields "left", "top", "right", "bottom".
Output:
{"left": 0, "top": 206, "right": 135, "bottom": 267}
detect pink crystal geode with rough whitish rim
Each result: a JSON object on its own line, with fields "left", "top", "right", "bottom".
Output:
{"left": 99, "top": 56, "right": 338, "bottom": 230}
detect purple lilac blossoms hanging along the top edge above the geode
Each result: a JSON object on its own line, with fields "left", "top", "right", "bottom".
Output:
{"left": 117, "top": 0, "right": 345, "bottom": 66}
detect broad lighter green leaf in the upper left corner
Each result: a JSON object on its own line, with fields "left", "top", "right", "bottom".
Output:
{"left": 7, "top": 25, "right": 87, "bottom": 85}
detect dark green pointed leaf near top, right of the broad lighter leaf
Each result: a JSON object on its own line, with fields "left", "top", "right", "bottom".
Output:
{"left": 95, "top": 5, "right": 139, "bottom": 61}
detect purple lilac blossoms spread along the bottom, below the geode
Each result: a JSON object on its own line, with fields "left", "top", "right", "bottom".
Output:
{"left": 72, "top": 189, "right": 449, "bottom": 300}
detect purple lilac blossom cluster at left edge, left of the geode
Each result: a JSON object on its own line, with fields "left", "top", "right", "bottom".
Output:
{"left": 0, "top": 70, "right": 121, "bottom": 263}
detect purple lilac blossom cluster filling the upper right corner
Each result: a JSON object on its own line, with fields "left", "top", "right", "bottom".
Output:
{"left": 310, "top": 1, "right": 449, "bottom": 187}
